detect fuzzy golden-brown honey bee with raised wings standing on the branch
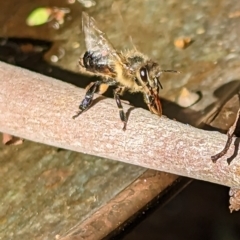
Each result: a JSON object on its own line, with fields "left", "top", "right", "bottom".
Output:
{"left": 73, "top": 12, "right": 178, "bottom": 130}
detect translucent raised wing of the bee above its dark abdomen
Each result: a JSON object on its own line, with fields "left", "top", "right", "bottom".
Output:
{"left": 82, "top": 12, "right": 121, "bottom": 61}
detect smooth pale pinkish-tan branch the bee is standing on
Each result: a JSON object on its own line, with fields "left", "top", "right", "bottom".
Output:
{"left": 0, "top": 63, "right": 240, "bottom": 187}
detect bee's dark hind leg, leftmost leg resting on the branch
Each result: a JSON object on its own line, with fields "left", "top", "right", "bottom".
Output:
{"left": 72, "top": 81, "right": 102, "bottom": 119}
